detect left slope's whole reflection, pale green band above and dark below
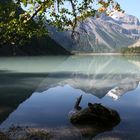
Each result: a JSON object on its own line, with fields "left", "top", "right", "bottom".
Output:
{"left": 0, "top": 56, "right": 67, "bottom": 123}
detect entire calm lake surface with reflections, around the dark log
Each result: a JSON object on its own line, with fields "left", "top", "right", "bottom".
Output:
{"left": 0, "top": 56, "right": 140, "bottom": 140}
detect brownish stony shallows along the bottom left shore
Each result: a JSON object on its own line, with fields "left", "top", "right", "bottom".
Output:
{"left": 0, "top": 126, "right": 81, "bottom": 140}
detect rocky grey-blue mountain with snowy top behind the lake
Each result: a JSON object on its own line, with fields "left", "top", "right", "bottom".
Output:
{"left": 50, "top": 13, "right": 140, "bottom": 53}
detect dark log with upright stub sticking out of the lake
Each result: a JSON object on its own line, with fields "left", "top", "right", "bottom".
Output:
{"left": 70, "top": 96, "right": 120, "bottom": 126}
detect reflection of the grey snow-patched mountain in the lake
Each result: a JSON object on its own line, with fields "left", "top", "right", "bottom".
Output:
{"left": 38, "top": 56, "right": 140, "bottom": 99}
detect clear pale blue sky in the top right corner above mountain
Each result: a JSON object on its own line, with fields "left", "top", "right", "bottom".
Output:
{"left": 116, "top": 0, "right": 140, "bottom": 19}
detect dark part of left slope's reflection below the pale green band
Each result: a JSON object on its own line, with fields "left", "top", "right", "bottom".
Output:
{"left": 0, "top": 71, "right": 46, "bottom": 123}
